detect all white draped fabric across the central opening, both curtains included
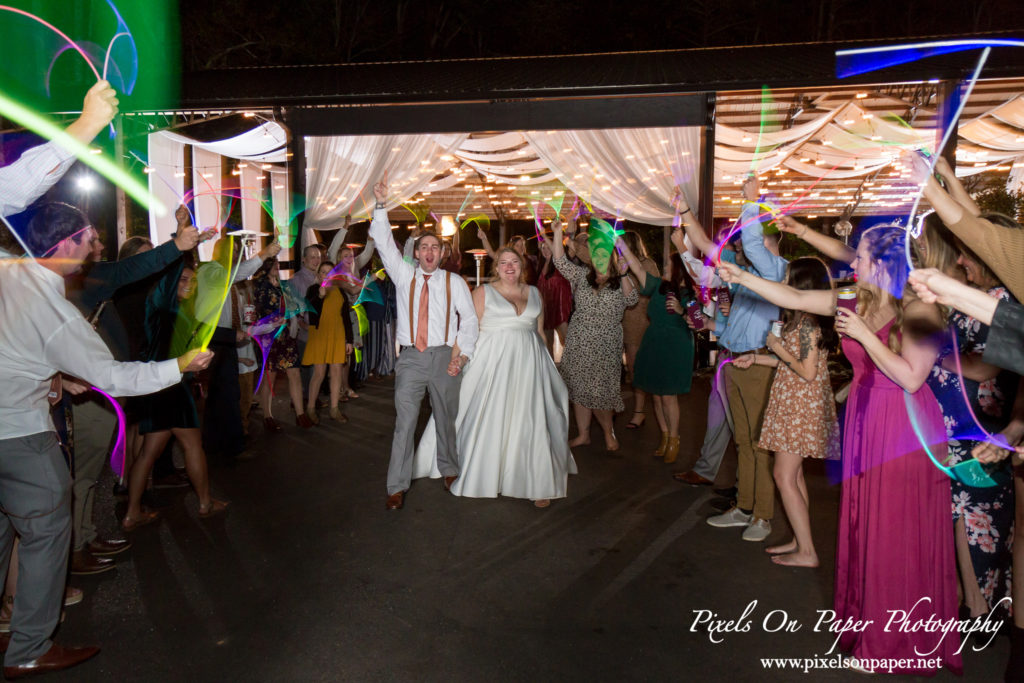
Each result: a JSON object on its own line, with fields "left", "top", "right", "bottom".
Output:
{"left": 305, "top": 127, "right": 700, "bottom": 229}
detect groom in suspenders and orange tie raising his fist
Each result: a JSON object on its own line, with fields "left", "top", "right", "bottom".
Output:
{"left": 370, "top": 173, "right": 478, "bottom": 510}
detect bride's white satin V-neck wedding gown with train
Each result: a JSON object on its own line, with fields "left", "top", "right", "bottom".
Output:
{"left": 413, "top": 285, "right": 577, "bottom": 501}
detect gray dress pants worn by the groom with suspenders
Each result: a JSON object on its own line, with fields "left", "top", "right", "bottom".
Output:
{"left": 387, "top": 346, "right": 462, "bottom": 496}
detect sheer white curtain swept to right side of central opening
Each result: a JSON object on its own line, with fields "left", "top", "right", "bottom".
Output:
{"left": 524, "top": 127, "right": 700, "bottom": 225}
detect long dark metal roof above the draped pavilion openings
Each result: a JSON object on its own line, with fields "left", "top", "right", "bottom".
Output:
{"left": 182, "top": 34, "right": 1024, "bottom": 109}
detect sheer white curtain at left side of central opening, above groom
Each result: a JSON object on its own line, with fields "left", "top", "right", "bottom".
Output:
{"left": 304, "top": 134, "right": 467, "bottom": 229}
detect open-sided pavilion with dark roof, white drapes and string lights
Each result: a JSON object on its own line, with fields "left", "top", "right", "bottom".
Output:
{"left": 125, "top": 35, "right": 1024, "bottom": 268}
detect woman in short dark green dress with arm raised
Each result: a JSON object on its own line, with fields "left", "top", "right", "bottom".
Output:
{"left": 616, "top": 238, "right": 693, "bottom": 463}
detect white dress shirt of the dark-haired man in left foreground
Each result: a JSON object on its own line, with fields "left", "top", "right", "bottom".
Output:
{"left": 0, "top": 259, "right": 181, "bottom": 439}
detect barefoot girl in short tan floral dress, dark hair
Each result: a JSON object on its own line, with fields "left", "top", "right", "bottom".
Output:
{"left": 733, "top": 258, "right": 840, "bottom": 567}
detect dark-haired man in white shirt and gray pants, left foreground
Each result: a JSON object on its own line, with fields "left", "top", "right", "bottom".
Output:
{"left": 0, "top": 202, "right": 211, "bottom": 679}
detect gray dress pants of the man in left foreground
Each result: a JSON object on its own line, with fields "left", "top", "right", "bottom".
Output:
{"left": 0, "top": 432, "right": 71, "bottom": 667}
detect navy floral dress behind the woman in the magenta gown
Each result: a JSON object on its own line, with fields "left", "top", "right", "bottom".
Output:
{"left": 928, "top": 287, "right": 1019, "bottom": 607}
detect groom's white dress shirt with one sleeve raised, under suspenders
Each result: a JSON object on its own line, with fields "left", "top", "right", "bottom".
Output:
{"left": 370, "top": 209, "right": 479, "bottom": 357}
